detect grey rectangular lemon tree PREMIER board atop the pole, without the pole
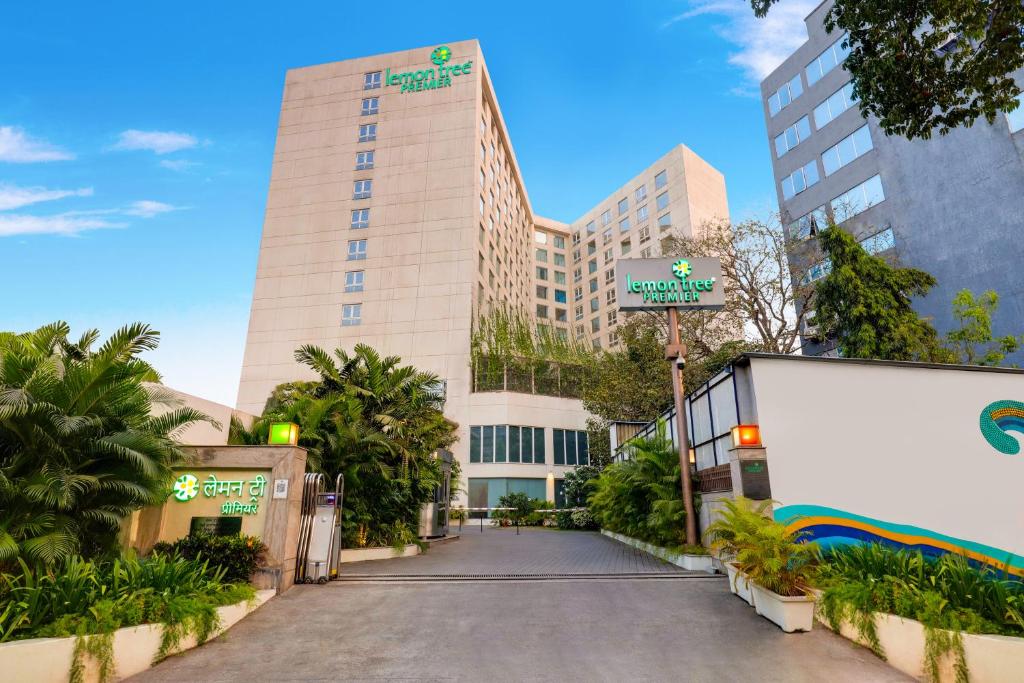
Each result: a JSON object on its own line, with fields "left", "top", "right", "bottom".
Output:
{"left": 615, "top": 257, "right": 725, "bottom": 310}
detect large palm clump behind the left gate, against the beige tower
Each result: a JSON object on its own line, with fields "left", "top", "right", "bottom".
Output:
{"left": 230, "top": 344, "right": 459, "bottom": 547}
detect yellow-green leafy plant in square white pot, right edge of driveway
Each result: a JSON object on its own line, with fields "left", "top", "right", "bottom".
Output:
{"left": 736, "top": 521, "right": 818, "bottom": 633}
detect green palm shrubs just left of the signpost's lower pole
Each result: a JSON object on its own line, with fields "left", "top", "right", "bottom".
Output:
{"left": 589, "top": 423, "right": 686, "bottom": 548}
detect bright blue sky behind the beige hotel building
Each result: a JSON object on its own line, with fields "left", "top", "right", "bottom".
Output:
{"left": 0, "top": 0, "right": 816, "bottom": 404}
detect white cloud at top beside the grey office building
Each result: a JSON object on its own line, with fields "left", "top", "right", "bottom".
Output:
{"left": 664, "top": 0, "right": 820, "bottom": 84}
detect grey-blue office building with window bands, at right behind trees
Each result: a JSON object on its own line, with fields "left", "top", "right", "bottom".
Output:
{"left": 761, "top": 1, "right": 1024, "bottom": 353}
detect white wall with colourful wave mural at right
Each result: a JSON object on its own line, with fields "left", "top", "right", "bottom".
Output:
{"left": 751, "top": 357, "right": 1024, "bottom": 574}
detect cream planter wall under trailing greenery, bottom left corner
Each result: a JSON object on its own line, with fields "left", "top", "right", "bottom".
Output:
{"left": 0, "top": 590, "right": 275, "bottom": 683}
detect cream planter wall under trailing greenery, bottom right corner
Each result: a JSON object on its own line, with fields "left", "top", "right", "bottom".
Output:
{"left": 821, "top": 612, "right": 1024, "bottom": 683}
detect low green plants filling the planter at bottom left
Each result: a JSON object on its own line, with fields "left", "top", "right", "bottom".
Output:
{"left": 0, "top": 554, "right": 255, "bottom": 652}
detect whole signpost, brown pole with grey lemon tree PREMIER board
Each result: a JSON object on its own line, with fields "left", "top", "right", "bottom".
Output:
{"left": 615, "top": 258, "right": 725, "bottom": 545}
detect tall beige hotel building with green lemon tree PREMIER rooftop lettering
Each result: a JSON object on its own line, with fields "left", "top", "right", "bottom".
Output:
{"left": 238, "top": 41, "right": 728, "bottom": 507}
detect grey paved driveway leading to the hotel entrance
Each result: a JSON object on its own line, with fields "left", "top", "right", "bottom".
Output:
{"left": 132, "top": 530, "right": 909, "bottom": 683}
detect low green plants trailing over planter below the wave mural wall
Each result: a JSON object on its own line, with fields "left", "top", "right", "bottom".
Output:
{"left": 818, "top": 544, "right": 1024, "bottom": 682}
